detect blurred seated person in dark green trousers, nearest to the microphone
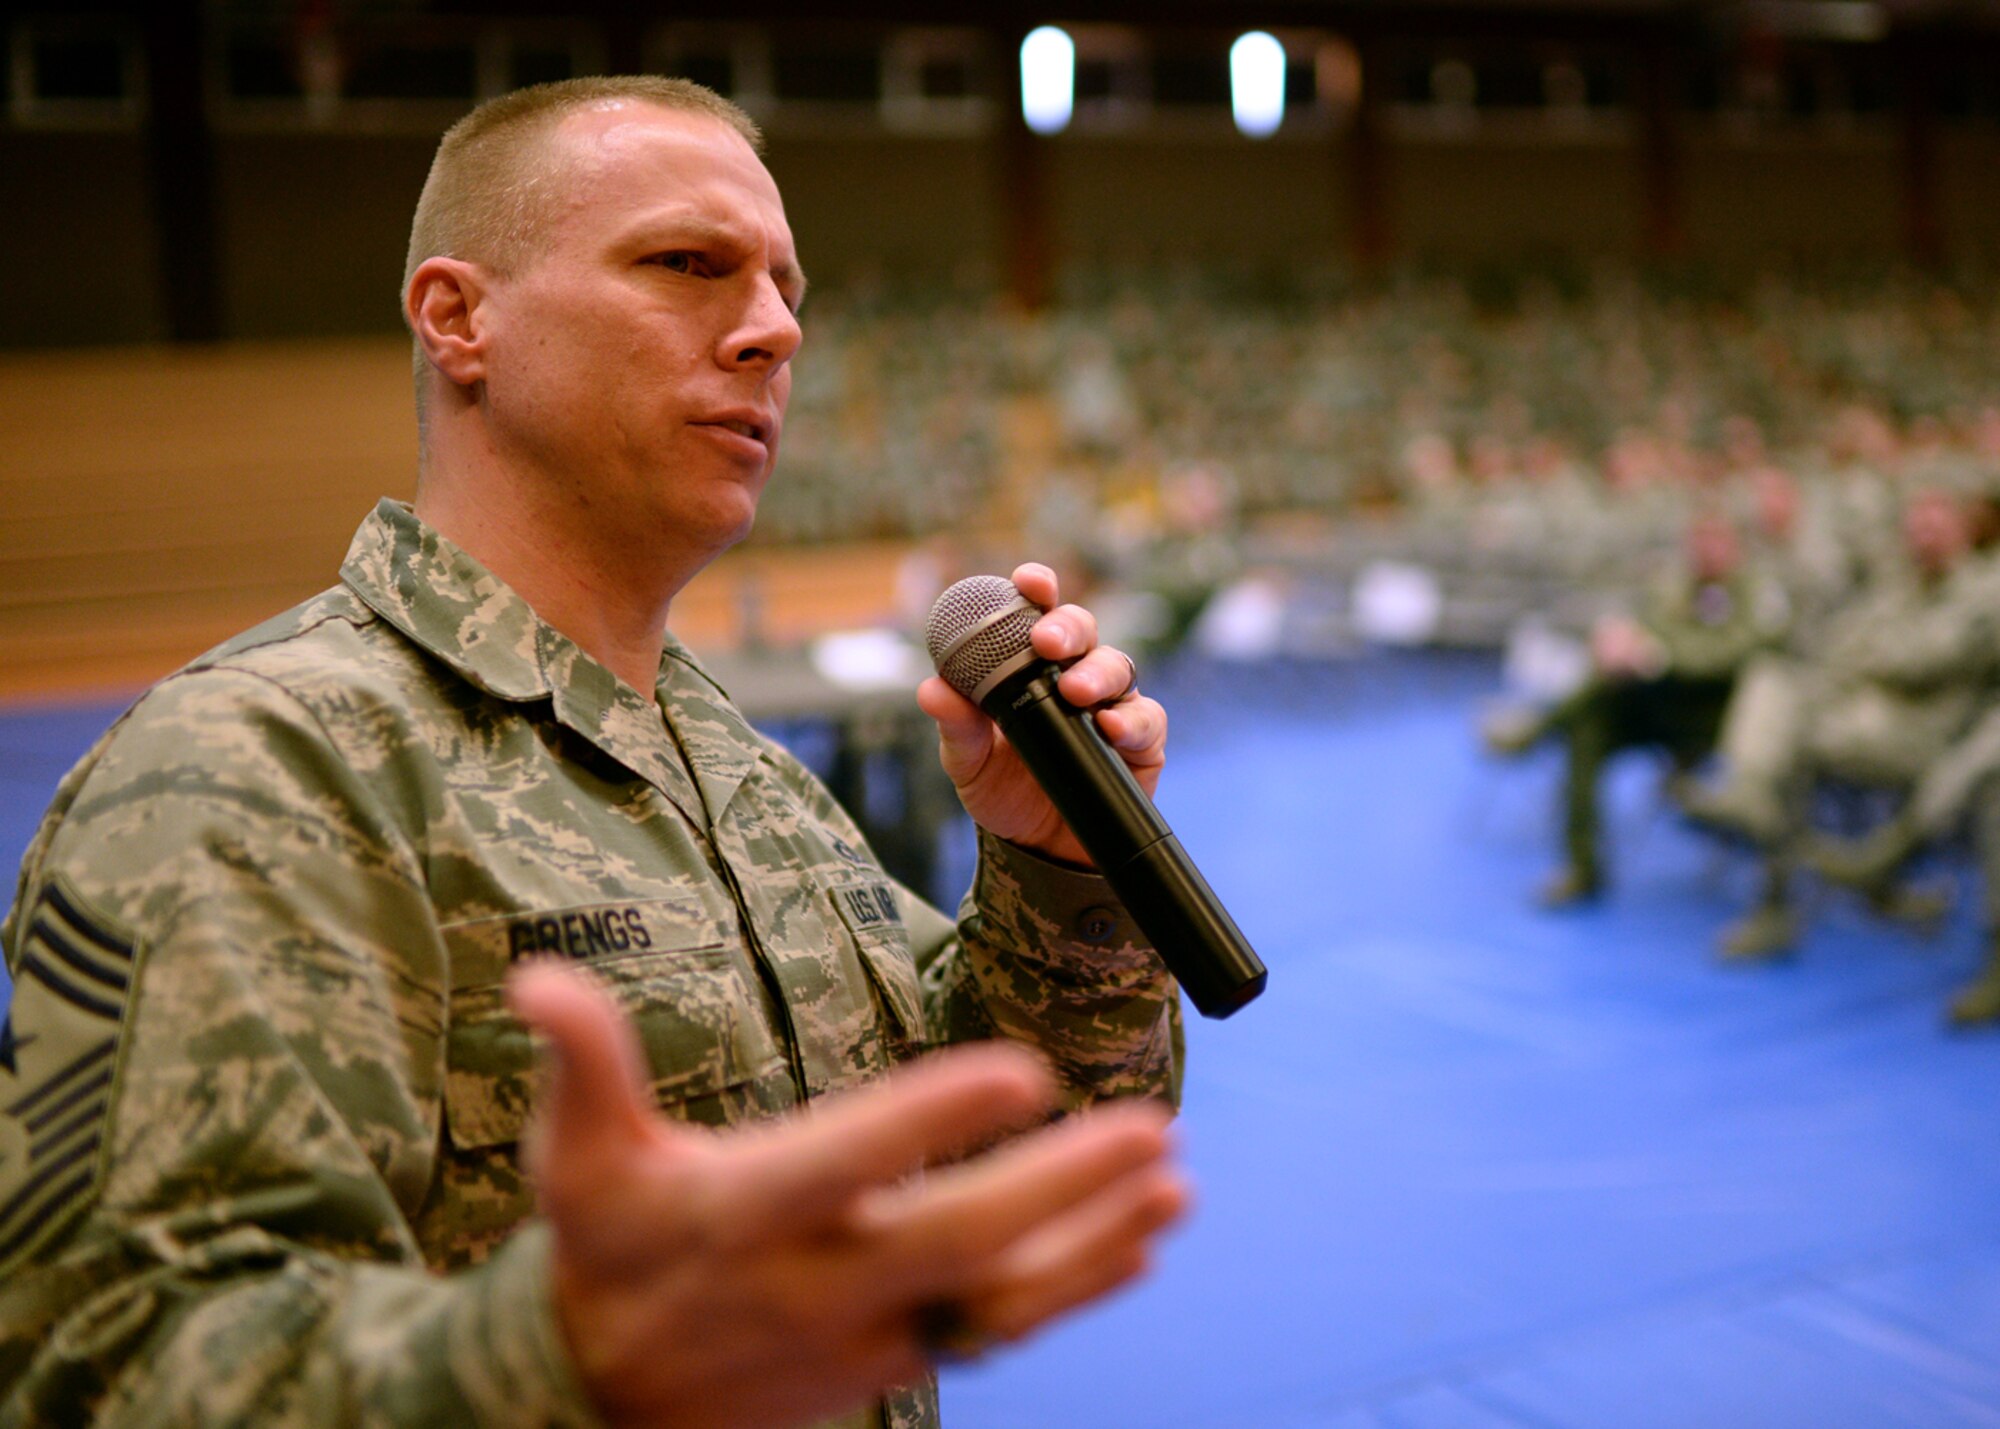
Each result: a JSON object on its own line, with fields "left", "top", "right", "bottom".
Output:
{"left": 1486, "top": 516, "right": 1784, "bottom": 907}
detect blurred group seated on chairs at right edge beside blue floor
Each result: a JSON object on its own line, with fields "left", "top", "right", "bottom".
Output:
{"left": 1484, "top": 412, "right": 2000, "bottom": 1023}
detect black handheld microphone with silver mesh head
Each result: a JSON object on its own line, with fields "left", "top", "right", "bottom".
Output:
{"left": 924, "top": 576, "right": 1270, "bottom": 1017}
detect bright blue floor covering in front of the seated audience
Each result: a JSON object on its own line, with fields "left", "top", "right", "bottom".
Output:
{"left": 0, "top": 656, "right": 2000, "bottom": 1429}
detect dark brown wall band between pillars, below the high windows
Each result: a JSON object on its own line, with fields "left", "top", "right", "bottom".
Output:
{"left": 0, "top": 122, "right": 2000, "bottom": 348}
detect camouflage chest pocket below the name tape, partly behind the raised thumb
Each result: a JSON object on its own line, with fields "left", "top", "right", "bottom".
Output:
{"left": 444, "top": 913, "right": 784, "bottom": 1149}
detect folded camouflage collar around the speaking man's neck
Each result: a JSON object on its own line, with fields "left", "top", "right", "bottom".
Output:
{"left": 340, "top": 498, "right": 758, "bottom": 825}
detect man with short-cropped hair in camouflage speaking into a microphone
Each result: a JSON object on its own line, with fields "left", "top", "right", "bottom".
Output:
{"left": 0, "top": 80, "right": 1182, "bottom": 1427}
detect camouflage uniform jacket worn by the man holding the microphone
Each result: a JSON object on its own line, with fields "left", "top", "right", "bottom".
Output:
{"left": 0, "top": 502, "right": 1182, "bottom": 1429}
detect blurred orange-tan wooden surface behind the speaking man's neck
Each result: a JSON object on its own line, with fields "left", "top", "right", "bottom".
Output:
{"left": 0, "top": 336, "right": 916, "bottom": 698}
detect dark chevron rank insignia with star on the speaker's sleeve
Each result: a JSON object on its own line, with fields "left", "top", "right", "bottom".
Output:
{"left": 0, "top": 881, "right": 132, "bottom": 1275}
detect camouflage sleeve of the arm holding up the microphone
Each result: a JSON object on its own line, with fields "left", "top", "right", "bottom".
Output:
{"left": 756, "top": 736, "right": 1186, "bottom": 1109}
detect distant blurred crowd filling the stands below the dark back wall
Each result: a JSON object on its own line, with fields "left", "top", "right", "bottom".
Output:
{"left": 758, "top": 262, "right": 2000, "bottom": 550}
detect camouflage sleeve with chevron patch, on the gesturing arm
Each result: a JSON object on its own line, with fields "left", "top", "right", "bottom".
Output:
{"left": 0, "top": 670, "right": 594, "bottom": 1425}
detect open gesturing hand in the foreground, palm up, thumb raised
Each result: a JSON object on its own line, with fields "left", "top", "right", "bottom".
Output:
{"left": 512, "top": 965, "right": 1186, "bottom": 1427}
